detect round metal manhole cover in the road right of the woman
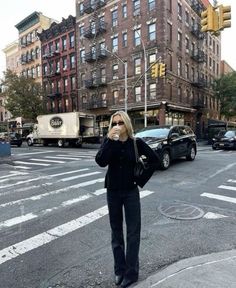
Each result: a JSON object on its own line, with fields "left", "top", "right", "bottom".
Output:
{"left": 158, "top": 202, "right": 204, "bottom": 220}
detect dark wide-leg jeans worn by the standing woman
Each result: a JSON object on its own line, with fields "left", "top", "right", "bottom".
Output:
{"left": 107, "top": 188, "right": 141, "bottom": 280}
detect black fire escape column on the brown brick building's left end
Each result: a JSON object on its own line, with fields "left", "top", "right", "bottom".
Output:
{"left": 83, "top": 0, "right": 107, "bottom": 110}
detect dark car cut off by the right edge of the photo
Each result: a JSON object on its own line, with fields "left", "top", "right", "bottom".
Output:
{"left": 212, "top": 130, "right": 236, "bottom": 150}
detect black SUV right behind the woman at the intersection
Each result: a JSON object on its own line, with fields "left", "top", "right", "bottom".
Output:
{"left": 135, "top": 125, "right": 197, "bottom": 170}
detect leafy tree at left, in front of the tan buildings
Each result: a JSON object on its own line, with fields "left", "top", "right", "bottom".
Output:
{"left": 2, "top": 70, "right": 46, "bottom": 121}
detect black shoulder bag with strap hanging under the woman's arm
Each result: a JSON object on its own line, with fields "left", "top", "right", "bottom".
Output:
{"left": 134, "top": 138, "right": 155, "bottom": 188}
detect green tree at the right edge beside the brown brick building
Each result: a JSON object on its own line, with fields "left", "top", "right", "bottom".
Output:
{"left": 213, "top": 72, "right": 236, "bottom": 119}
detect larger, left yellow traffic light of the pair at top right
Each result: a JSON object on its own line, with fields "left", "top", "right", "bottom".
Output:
{"left": 201, "top": 5, "right": 218, "bottom": 32}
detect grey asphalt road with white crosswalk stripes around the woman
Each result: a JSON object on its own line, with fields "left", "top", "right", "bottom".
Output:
{"left": 0, "top": 146, "right": 236, "bottom": 288}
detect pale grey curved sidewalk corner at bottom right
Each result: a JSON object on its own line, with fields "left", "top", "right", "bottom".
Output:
{"left": 134, "top": 250, "right": 236, "bottom": 288}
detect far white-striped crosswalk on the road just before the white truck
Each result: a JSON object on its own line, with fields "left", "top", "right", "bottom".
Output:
{"left": 13, "top": 151, "right": 95, "bottom": 170}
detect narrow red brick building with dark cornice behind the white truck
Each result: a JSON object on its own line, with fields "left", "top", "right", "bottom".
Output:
{"left": 39, "top": 16, "right": 78, "bottom": 113}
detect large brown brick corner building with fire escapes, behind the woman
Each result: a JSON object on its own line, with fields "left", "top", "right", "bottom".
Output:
{"left": 76, "top": 0, "right": 220, "bottom": 138}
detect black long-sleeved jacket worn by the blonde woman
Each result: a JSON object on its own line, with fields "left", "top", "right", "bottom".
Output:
{"left": 95, "top": 137, "right": 159, "bottom": 191}
